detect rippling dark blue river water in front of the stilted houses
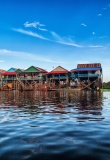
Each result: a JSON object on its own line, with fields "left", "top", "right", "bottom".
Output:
{"left": 0, "top": 91, "right": 110, "bottom": 160}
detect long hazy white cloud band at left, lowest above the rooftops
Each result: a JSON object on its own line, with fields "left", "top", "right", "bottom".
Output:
{"left": 0, "top": 49, "right": 66, "bottom": 63}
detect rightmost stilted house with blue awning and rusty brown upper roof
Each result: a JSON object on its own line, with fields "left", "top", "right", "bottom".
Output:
{"left": 71, "top": 63, "right": 103, "bottom": 89}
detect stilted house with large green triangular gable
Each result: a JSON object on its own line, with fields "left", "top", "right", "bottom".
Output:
{"left": 18, "top": 66, "right": 47, "bottom": 90}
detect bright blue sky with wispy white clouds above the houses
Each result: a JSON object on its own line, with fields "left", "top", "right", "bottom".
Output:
{"left": 0, "top": 0, "right": 110, "bottom": 81}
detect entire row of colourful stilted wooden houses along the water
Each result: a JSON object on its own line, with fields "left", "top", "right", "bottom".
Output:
{"left": 0, "top": 63, "right": 103, "bottom": 90}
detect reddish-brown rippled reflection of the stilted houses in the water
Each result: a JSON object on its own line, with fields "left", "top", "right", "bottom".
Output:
{"left": 0, "top": 91, "right": 103, "bottom": 120}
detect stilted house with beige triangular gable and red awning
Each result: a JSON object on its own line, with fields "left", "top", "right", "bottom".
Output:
{"left": 46, "top": 66, "right": 69, "bottom": 88}
